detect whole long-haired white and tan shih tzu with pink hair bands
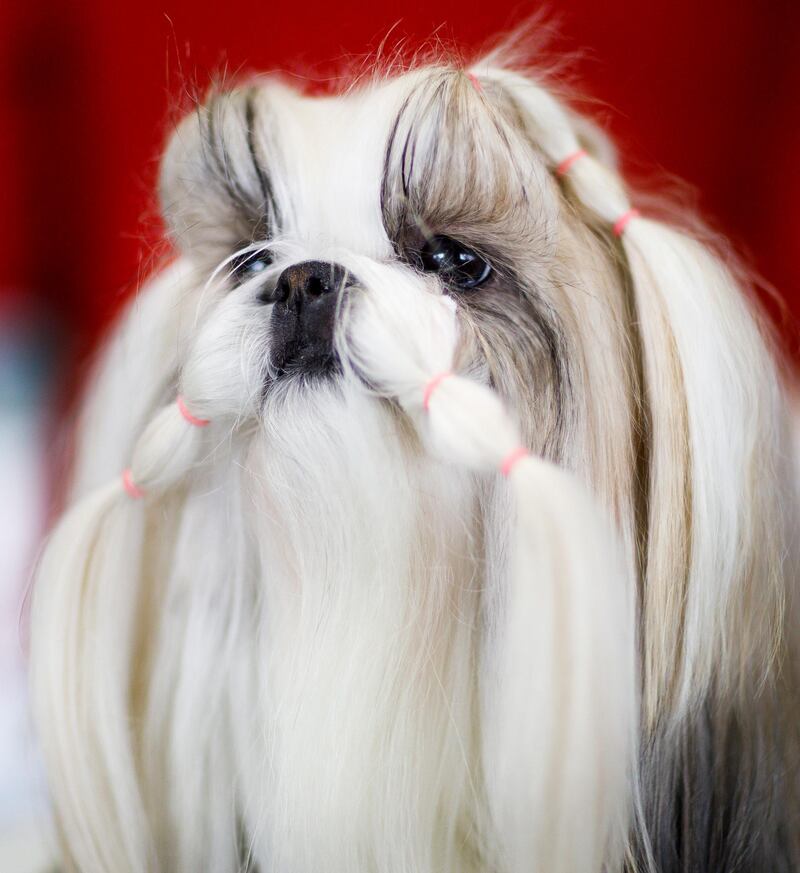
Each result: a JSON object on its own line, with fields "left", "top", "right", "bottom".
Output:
{"left": 31, "top": 37, "right": 800, "bottom": 873}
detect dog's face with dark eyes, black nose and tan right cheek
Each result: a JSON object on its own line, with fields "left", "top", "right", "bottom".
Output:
{"left": 162, "top": 68, "right": 632, "bottom": 484}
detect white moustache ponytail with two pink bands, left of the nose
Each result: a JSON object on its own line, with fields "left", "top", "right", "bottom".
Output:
{"left": 26, "top": 284, "right": 256, "bottom": 873}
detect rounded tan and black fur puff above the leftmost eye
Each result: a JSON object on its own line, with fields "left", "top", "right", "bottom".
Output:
{"left": 159, "top": 86, "right": 271, "bottom": 263}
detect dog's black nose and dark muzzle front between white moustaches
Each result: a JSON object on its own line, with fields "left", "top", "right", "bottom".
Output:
{"left": 270, "top": 261, "right": 352, "bottom": 375}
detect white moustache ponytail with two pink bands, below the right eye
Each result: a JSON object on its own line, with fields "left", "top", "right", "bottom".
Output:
{"left": 343, "top": 252, "right": 636, "bottom": 873}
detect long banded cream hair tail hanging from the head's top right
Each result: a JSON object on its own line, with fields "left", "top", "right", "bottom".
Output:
{"left": 476, "top": 65, "right": 793, "bottom": 720}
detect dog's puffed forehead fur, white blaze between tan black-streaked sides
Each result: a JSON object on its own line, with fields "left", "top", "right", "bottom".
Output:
{"left": 162, "top": 68, "right": 556, "bottom": 260}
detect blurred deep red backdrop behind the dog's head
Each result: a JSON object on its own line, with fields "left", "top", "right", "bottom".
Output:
{"left": 0, "top": 0, "right": 800, "bottom": 357}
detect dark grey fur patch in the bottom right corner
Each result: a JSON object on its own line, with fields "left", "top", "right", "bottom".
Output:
{"left": 635, "top": 692, "right": 798, "bottom": 873}
